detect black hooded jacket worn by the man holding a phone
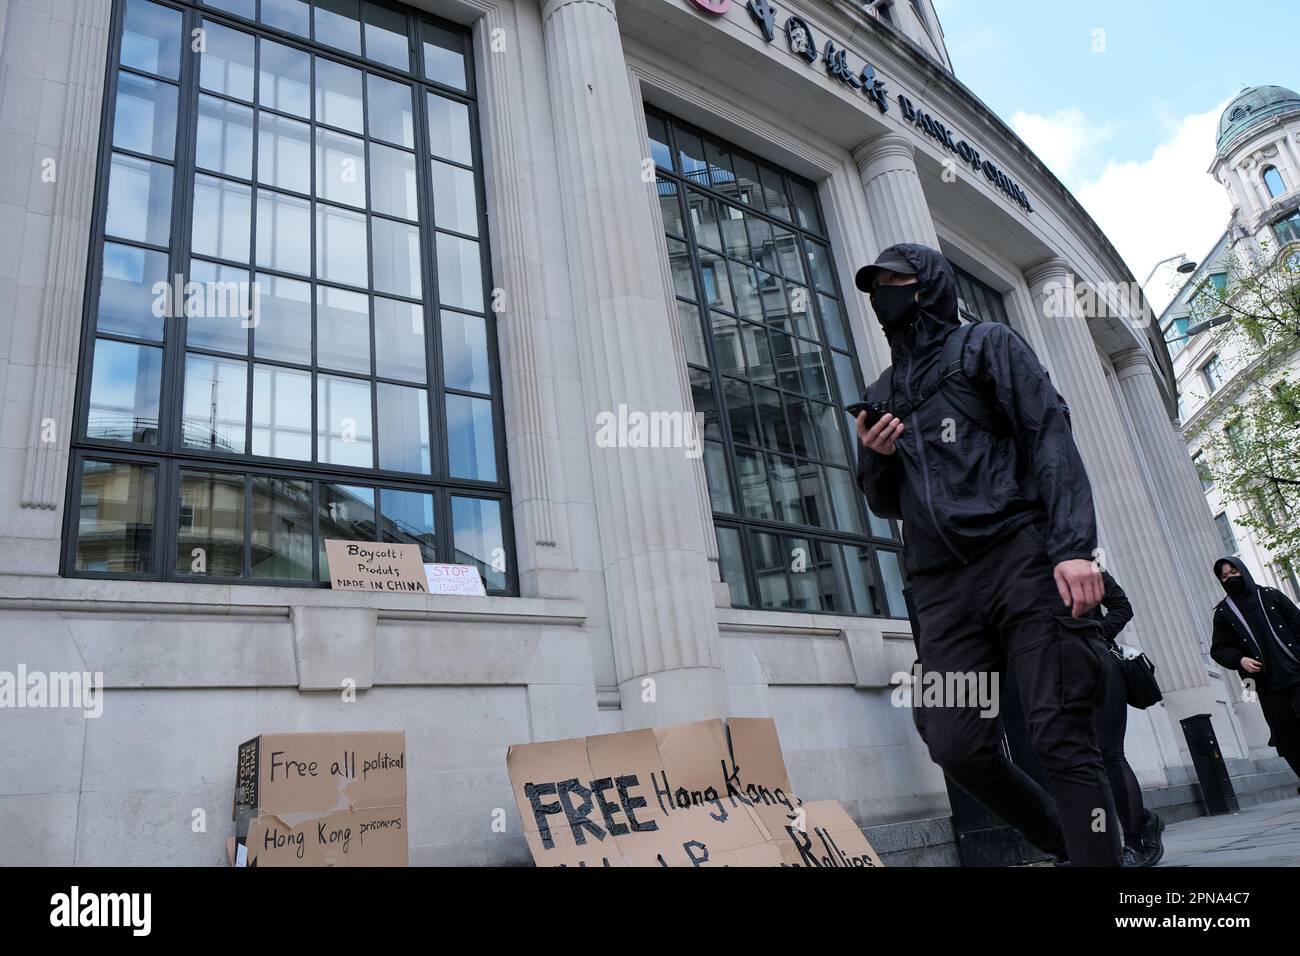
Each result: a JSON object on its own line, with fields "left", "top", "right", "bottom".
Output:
{"left": 858, "top": 243, "right": 1097, "bottom": 572}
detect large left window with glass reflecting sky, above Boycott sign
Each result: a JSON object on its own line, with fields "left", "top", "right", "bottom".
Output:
{"left": 64, "top": 0, "right": 515, "bottom": 593}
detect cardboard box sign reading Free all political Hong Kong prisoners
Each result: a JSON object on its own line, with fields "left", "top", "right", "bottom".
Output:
{"left": 230, "top": 731, "right": 410, "bottom": 866}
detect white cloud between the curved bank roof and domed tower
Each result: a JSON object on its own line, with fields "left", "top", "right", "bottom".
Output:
{"left": 1071, "top": 104, "right": 1232, "bottom": 315}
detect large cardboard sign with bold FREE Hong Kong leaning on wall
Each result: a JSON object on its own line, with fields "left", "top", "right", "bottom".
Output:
{"left": 506, "top": 717, "right": 881, "bottom": 866}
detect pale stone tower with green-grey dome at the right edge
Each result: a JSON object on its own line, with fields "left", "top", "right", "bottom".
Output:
{"left": 1209, "top": 86, "right": 1300, "bottom": 251}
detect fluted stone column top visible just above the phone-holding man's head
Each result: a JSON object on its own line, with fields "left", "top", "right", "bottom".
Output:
{"left": 853, "top": 133, "right": 939, "bottom": 248}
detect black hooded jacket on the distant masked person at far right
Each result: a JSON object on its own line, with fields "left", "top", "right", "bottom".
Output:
{"left": 1210, "top": 558, "right": 1300, "bottom": 691}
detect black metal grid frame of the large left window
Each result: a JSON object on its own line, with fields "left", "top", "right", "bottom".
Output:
{"left": 60, "top": 0, "right": 519, "bottom": 596}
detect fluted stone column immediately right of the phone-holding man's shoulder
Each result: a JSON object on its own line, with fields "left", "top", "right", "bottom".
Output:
{"left": 1026, "top": 259, "right": 1213, "bottom": 719}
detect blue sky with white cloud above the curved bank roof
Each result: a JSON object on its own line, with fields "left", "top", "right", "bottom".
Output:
{"left": 935, "top": 0, "right": 1300, "bottom": 308}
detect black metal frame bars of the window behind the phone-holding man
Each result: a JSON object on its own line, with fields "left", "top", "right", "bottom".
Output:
{"left": 645, "top": 104, "right": 907, "bottom": 620}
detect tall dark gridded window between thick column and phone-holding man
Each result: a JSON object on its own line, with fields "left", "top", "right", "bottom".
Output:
{"left": 646, "top": 109, "right": 902, "bottom": 617}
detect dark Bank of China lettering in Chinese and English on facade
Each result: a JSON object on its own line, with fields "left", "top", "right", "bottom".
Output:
{"left": 689, "top": 0, "right": 1034, "bottom": 212}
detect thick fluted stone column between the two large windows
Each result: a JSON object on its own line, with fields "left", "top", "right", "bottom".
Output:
{"left": 541, "top": 0, "right": 727, "bottom": 728}
